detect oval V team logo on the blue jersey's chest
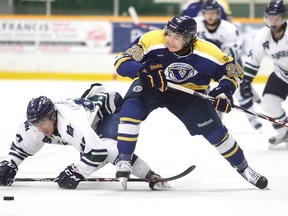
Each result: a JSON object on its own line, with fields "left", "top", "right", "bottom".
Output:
{"left": 164, "top": 62, "right": 198, "bottom": 82}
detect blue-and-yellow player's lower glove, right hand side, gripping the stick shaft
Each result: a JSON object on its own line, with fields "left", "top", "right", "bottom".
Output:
{"left": 209, "top": 86, "right": 233, "bottom": 113}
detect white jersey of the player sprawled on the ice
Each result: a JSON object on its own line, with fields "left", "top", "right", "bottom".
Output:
{"left": 7, "top": 86, "right": 117, "bottom": 177}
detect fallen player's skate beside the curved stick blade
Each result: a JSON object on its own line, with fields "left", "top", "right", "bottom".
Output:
{"left": 145, "top": 170, "right": 171, "bottom": 191}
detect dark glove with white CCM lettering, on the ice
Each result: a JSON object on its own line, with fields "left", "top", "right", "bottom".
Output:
{"left": 55, "top": 165, "right": 85, "bottom": 189}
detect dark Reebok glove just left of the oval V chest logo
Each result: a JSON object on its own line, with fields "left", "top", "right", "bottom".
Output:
{"left": 139, "top": 59, "right": 167, "bottom": 92}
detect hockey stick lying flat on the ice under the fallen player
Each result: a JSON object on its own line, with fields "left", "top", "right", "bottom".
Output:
{"left": 14, "top": 165, "right": 196, "bottom": 182}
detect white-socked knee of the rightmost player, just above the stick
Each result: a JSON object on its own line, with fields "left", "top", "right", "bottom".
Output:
{"left": 262, "top": 94, "right": 285, "bottom": 118}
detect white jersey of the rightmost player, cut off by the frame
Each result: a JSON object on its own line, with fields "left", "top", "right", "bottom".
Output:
{"left": 244, "top": 21, "right": 288, "bottom": 84}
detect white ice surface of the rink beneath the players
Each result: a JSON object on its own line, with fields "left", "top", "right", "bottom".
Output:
{"left": 0, "top": 80, "right": 288, "bottom": 216}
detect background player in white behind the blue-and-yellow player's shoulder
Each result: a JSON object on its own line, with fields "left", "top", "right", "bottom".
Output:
{"left": 194, "top": 0, "right": 262, "bottom": 129}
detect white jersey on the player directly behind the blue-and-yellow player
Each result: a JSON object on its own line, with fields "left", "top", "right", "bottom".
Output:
{"left": 194, "top": 17, "right": 243, "bottom": 61}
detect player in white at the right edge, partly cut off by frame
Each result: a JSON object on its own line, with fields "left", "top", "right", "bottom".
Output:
{"left": 240, "top": 0, "right": 288, "bottom": 149}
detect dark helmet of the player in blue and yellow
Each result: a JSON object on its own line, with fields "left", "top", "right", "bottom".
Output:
{"left": 164, "top": 15, "right": 197, "bottom": 43}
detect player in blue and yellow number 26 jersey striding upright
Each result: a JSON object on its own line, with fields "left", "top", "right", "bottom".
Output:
{"left": 115, "top": 15, "right": 268, "bottom": 189}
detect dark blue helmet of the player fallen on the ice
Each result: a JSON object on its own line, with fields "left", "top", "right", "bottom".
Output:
{"left": 26, "top": 96, "right": 56, "bottom": 125}
